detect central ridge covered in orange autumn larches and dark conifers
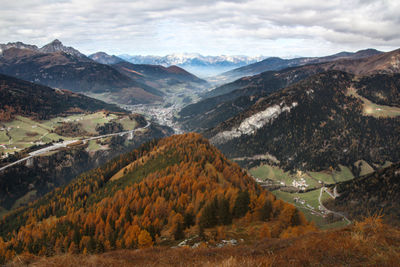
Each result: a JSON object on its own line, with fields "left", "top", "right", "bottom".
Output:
{"left": 0, "top": 134, "right": 315, "bottom": 262}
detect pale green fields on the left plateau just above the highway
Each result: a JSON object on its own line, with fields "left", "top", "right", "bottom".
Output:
{"left": 0, "top": 112, "right": 137, "bottom": 154}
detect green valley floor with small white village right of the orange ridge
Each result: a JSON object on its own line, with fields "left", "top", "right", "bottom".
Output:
{"left": 249, "top": 161, "right": 384, "bottom": 229}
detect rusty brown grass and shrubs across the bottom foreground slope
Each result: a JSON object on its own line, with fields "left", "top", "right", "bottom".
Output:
{"left": 9, "top": 217, "right": 400, "bottom": 267}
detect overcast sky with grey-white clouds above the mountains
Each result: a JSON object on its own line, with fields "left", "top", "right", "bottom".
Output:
{"left": 0, "top": 0, "right": 400, "bottom": 57}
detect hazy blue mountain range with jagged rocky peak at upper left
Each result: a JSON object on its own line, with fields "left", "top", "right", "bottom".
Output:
{"left": 0, "top": 40, "right": 205, "bottom": 104}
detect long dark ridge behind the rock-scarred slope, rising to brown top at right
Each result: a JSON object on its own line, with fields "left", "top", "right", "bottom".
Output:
{"left": 178, "top": 50, "right": 400, "bottom": 131}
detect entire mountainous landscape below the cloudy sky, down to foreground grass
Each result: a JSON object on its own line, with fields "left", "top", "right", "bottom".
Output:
{"left": 0, "top": 37, "right": 400, "bottom": 266}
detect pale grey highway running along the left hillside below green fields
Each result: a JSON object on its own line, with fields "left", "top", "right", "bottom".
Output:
{"left": 0, "top": 122, "right": 151, "bottom": 172}
